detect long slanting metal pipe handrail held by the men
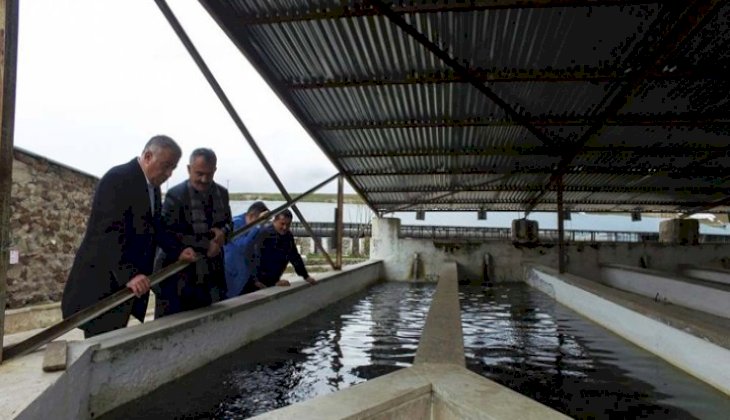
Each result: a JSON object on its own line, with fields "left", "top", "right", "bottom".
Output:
{"left": 3, "top": 175, "right": 337, "bottom": 359}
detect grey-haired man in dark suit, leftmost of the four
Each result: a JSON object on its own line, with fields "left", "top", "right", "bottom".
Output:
{"left": 61, "top": 136, "right": 195, "bottom": 338}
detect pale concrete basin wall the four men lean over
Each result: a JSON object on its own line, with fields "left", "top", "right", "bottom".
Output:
{"left": 18, "top": 261, "right": 382, "bottom": 419}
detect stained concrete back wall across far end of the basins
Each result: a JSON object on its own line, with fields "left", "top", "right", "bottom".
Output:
{"left": 370, "top": 218, "right": 730, "bottom": 283}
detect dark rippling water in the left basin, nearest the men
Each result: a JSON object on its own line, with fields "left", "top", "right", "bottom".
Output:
{"left": 102, "top": 283, "right": 434, "bottom": 419}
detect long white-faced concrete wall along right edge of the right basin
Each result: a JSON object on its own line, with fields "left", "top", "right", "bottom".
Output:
{"left": 524, "top": 265, "right": 730, "bottom": 395}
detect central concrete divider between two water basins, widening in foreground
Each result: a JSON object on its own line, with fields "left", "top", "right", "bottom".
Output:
{"left": 256, "top": 262, "right": 567, "bottom": 420}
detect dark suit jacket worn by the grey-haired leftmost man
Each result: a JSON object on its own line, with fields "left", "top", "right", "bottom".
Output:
{"left": 61, "top": 158, "right": 182, "bottom": 328}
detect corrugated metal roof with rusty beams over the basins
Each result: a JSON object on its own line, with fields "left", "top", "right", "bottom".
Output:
{"left": 201, "top": 0, "right": 730, "bottom": 212}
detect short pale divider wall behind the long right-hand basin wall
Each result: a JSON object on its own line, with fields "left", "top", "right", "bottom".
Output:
{"left": 601, "top": 264, "right": 730, "bottom": 318}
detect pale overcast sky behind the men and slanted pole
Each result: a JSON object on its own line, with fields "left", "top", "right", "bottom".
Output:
{"left": 15, "top": 0, "right": 336, "bottom": 192}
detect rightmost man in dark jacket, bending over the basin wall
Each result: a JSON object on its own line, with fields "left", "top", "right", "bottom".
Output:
{"left": 243, "top": 210, "right": 316, "bottom": 293}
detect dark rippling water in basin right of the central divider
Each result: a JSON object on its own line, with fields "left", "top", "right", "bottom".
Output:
{"left": 461, "top": 283, "right": 730, "bottom": 419}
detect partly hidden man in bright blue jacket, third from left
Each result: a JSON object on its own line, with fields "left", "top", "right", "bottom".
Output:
{"left": 223, "top": 201, "right": 269, "bottom": 298}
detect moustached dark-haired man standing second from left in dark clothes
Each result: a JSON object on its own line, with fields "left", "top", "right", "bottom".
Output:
{"left": 155, "top": 148, "right": 233, "bottom": 318}
